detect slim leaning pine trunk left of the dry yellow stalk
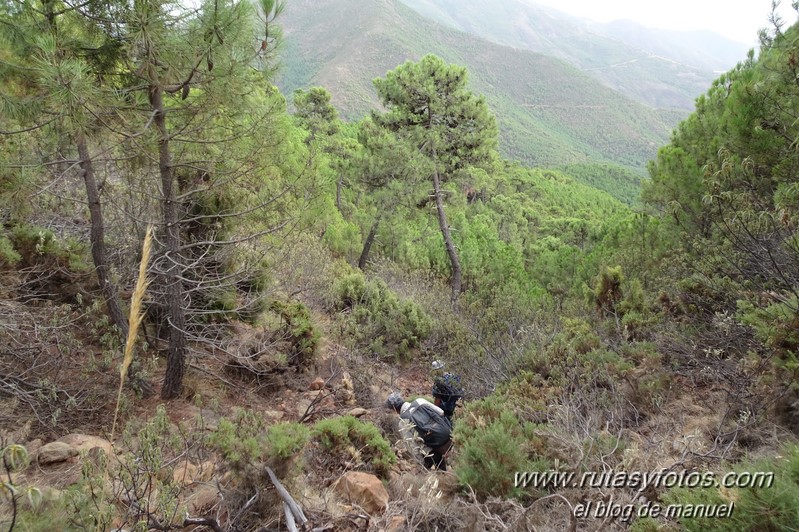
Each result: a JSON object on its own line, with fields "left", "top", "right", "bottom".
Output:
{"left": 76, "top": 134, "right": 128, "bottom": 343}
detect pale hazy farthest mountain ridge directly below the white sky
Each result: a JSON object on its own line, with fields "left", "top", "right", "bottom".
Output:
{"left": 401, "top": 0, "right": 747, "bottom": 111}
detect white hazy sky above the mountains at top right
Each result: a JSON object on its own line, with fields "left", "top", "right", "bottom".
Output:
{"left": 532, "top": 0, "right": 796, "bottom": 46}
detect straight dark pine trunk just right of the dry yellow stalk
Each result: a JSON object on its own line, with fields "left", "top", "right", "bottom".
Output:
{"left": 150, "top": 86, "right": 187, "bottom": 399}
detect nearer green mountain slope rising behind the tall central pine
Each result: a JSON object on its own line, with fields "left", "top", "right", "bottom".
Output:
{"left": 278, "top": 0, "right": 680, "bottom": 171}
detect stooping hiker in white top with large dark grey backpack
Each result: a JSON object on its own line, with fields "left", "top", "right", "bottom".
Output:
{"left": 386, "top": 392, "right": 452, "bottom": 471}
